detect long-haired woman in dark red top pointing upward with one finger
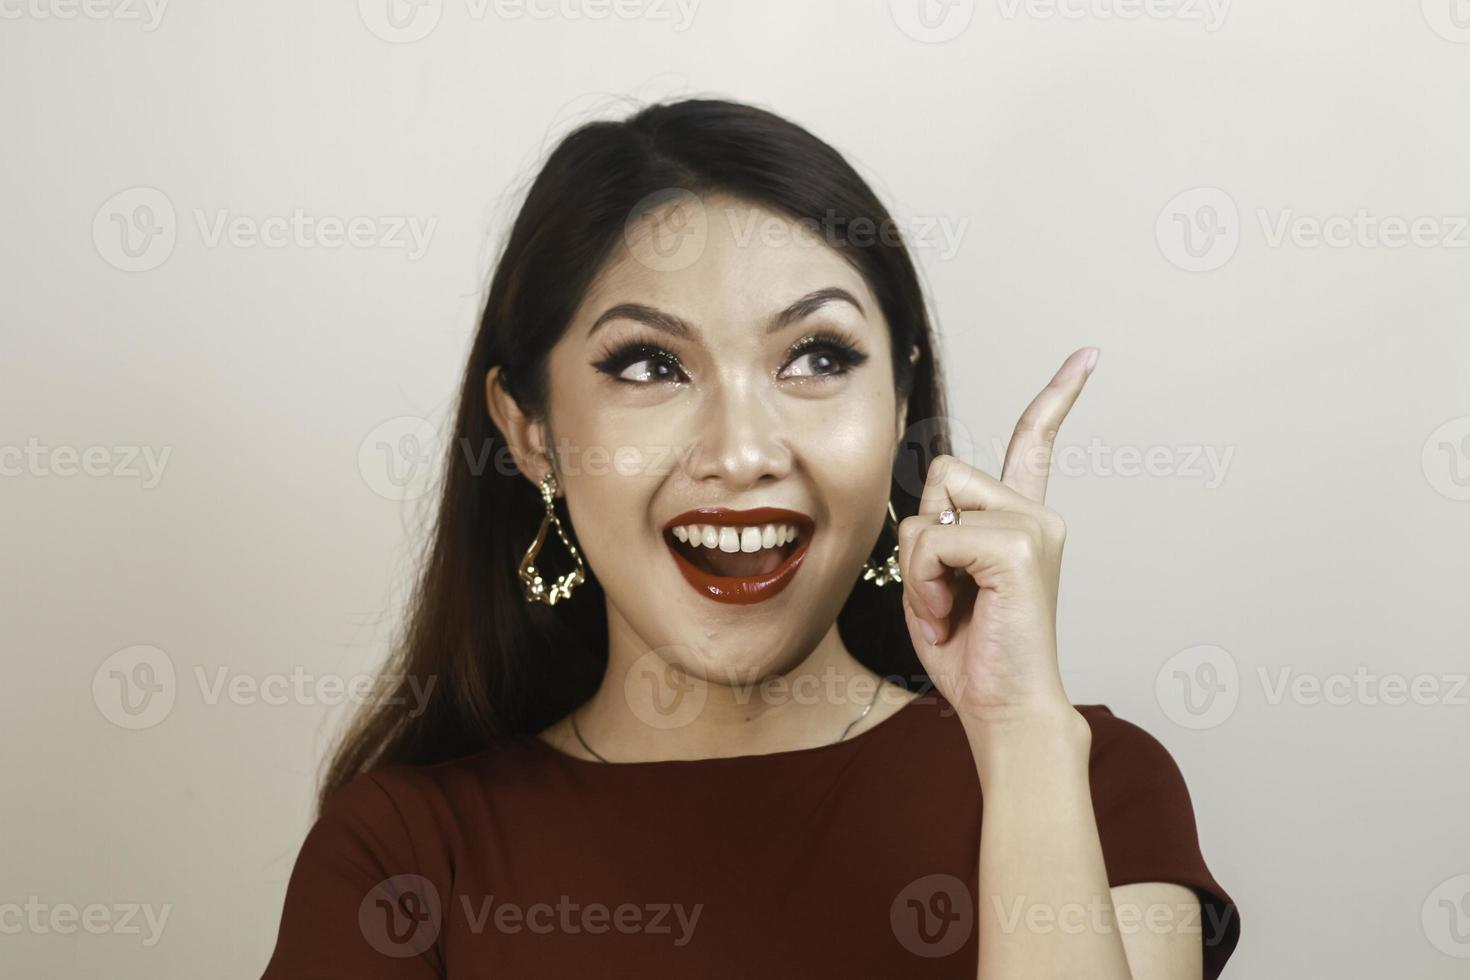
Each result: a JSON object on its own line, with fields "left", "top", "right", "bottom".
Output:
{"left": 265, "top": 100, "right": 1239, "bottom": 980}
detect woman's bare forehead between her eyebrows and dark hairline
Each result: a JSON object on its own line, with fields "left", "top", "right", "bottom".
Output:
{"left": 573, "top": 194, "right": 879, "bottom": 329}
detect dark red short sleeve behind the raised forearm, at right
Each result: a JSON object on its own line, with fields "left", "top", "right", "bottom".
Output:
{"left": 1079, "top": 705, "right": 1241, "bottom": 980}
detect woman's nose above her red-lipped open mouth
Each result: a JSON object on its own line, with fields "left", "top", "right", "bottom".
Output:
{"left": 688, "top": 379, "right": 792, "bottom": 491}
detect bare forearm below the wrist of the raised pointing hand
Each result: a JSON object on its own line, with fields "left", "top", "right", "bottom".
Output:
{"left": 966, "top": 705, "right": 1130, "bottom": 980}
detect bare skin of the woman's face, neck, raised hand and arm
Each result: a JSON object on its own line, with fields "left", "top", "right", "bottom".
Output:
{"left": 485, "top": 195, "right": 1202, "bottom": 980}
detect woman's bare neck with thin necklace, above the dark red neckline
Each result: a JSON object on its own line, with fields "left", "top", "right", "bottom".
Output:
{"left": 576, "top": 623, "right": 881, "bottom": 763}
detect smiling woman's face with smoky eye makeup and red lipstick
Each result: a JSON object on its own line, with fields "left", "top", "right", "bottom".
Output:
{"left": 517, "top": 189, "right": 904, "bottom": 683}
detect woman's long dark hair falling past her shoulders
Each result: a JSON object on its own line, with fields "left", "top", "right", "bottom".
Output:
{"left": 318, "top": 98, "right": 950, "bottom": 808}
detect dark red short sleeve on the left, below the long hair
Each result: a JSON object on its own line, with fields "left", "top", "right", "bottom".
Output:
{"left": 262, "top": 773, "right": 444, "bottom": 980}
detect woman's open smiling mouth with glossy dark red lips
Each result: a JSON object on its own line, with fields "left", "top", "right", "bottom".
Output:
{"left": 663, "top": 507, "right": 814, "bottom": 604}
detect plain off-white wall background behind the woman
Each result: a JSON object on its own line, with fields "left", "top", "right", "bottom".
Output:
{"left": 0, "top": 0, "right": 1470, "bottom": 980}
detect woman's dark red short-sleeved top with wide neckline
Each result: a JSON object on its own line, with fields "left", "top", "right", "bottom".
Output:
{"left": 263, "top": 692, "right": 1241, "bottom": 980}
